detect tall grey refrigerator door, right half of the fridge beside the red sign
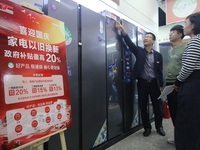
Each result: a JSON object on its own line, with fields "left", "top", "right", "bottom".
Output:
{"left": 81, "top": 6, "right": 107, "bottom": 150}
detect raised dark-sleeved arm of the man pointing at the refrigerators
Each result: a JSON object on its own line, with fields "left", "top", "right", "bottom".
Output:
{"left": 116, "top": 21, "right": 138, "bottom": 57}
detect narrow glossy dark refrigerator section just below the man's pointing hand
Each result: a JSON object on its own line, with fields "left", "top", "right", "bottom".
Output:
{"left": 104, "top": 14, "right": 124, "bottom": 140}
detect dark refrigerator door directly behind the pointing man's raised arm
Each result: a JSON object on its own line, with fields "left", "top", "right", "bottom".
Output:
{"left": 122, "top": 20, "right": 139, "bottom": 131}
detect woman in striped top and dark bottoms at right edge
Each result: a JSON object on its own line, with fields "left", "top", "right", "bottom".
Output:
{"left": 174, "top": 12, "right": 200, "bottom": 150}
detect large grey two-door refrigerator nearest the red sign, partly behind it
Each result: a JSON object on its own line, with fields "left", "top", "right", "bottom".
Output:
{"left": 44, "top": 0, "right": 107, "bottom": 150}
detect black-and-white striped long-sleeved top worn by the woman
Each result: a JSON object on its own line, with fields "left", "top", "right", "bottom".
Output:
{"left": 177, "top": 34, "right": 200, "bottom": 82}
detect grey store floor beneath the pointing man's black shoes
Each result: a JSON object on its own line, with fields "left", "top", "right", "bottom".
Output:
{"left": 106, "top": 119, "right": 175, "bottom": 150}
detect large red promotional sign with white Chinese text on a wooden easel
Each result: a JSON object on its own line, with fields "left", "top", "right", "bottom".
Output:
{"left": 0, "top": 0, "right": 72, "bottom": 150}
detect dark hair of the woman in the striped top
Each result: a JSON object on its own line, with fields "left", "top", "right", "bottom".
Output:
{"left": 186, "top": 12, "right": 200, "bottom": 35}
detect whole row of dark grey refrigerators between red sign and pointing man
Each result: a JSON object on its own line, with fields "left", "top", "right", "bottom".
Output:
{"left": 43, "top": 0, "right": 153, "bottom": 150}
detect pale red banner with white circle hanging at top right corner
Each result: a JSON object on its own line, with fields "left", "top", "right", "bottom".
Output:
{"left": 166, "top": 0, "right": 200, "bottom": 24}
